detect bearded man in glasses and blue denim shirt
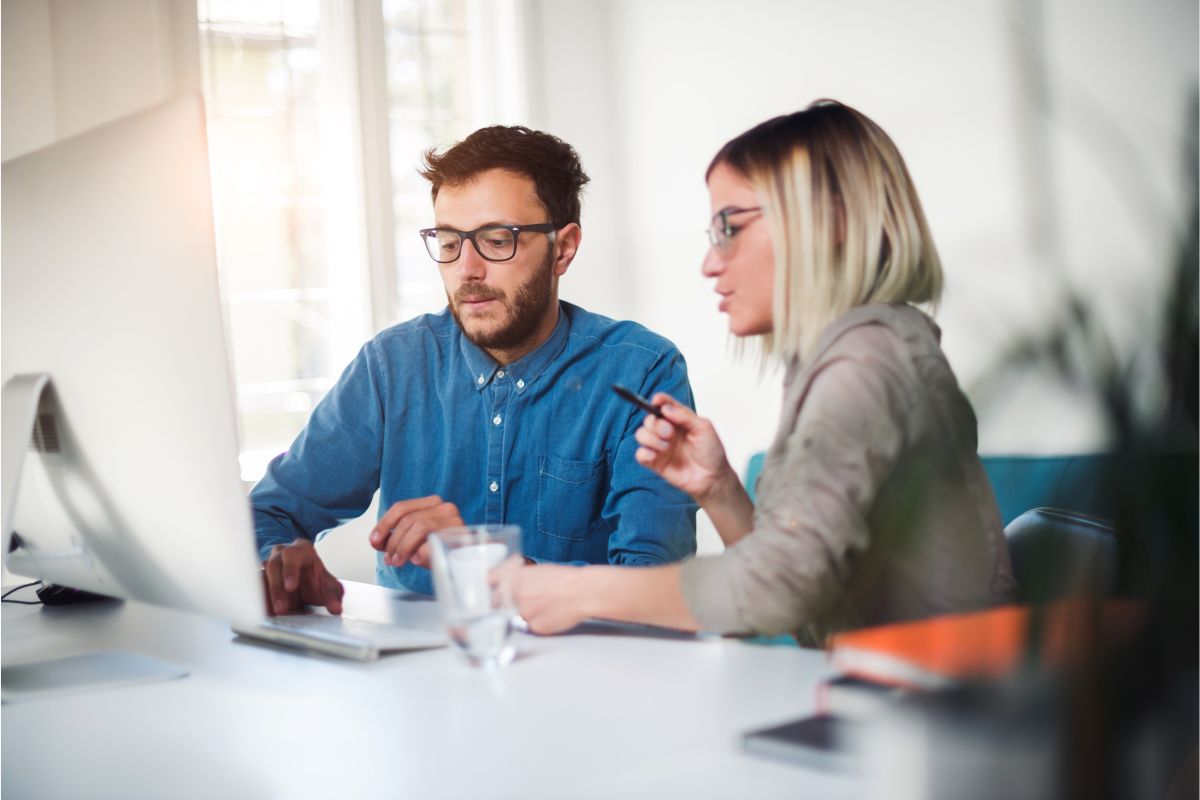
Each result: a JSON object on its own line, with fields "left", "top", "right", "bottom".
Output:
{"left": 251, "top": 126, "right": 696, "bottom": 614}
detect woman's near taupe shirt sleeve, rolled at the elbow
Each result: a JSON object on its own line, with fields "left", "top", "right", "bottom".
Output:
{"left": 683, "top": 325, "right": 917, "bottom": 633}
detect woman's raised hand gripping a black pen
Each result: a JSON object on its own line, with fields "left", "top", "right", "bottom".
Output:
{"left": 635, "top": 392, "right": 738, "bottom": 505}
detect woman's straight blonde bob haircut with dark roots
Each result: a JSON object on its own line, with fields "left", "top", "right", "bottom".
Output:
{"left": 706, "top": 100, "right": 942, "bottom": 360}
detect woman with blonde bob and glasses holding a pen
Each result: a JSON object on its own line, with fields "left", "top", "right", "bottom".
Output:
{"left": 517, "top": 101, "right": 1015, "bottom": 644}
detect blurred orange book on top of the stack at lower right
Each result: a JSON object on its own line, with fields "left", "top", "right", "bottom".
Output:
{"left": 828, "top": 600, "right": 1145, "bottom": 688}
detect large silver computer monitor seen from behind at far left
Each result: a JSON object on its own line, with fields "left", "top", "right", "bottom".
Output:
{"left": 0, "top": 96, "right": 265, "bottom": 622}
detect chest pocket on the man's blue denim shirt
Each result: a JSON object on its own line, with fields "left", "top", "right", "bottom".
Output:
{"left": 538, "top": 453, "right": 608, "bottom": 542}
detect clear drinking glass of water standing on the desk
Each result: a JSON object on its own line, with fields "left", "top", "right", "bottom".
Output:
{"left": 430, "top": 525, "right": 524, "bottom": 664}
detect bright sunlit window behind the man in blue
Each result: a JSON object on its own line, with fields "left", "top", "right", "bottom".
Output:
{"left": 198, "top": 0, "right": 523, "bottom": 481}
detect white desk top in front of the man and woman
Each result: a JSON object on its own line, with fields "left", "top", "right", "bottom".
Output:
{"left": 0, "top": 584, "right": 858, "bottom": 799}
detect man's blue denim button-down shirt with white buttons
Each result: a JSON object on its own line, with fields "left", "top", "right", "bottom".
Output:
{"left": 251, "top": 302, "right": 696, "bottom": 594}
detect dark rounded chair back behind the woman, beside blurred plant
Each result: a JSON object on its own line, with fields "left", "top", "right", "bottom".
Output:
{"left": 1004, "top": 507, "right": 1117, "bottom": 604}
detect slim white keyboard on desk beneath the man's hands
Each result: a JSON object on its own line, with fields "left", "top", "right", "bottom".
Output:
{"left": 233, "top": 581, "right": 450, "bottom": 661}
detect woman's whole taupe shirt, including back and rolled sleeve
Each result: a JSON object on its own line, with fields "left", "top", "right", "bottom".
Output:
{"left": 683, "top": 305, "right": 1016, "bottom": 644}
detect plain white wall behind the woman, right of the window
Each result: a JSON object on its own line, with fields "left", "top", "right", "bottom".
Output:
{"left": 532, "top": 0, "right": 1198, "bottom": 489}
